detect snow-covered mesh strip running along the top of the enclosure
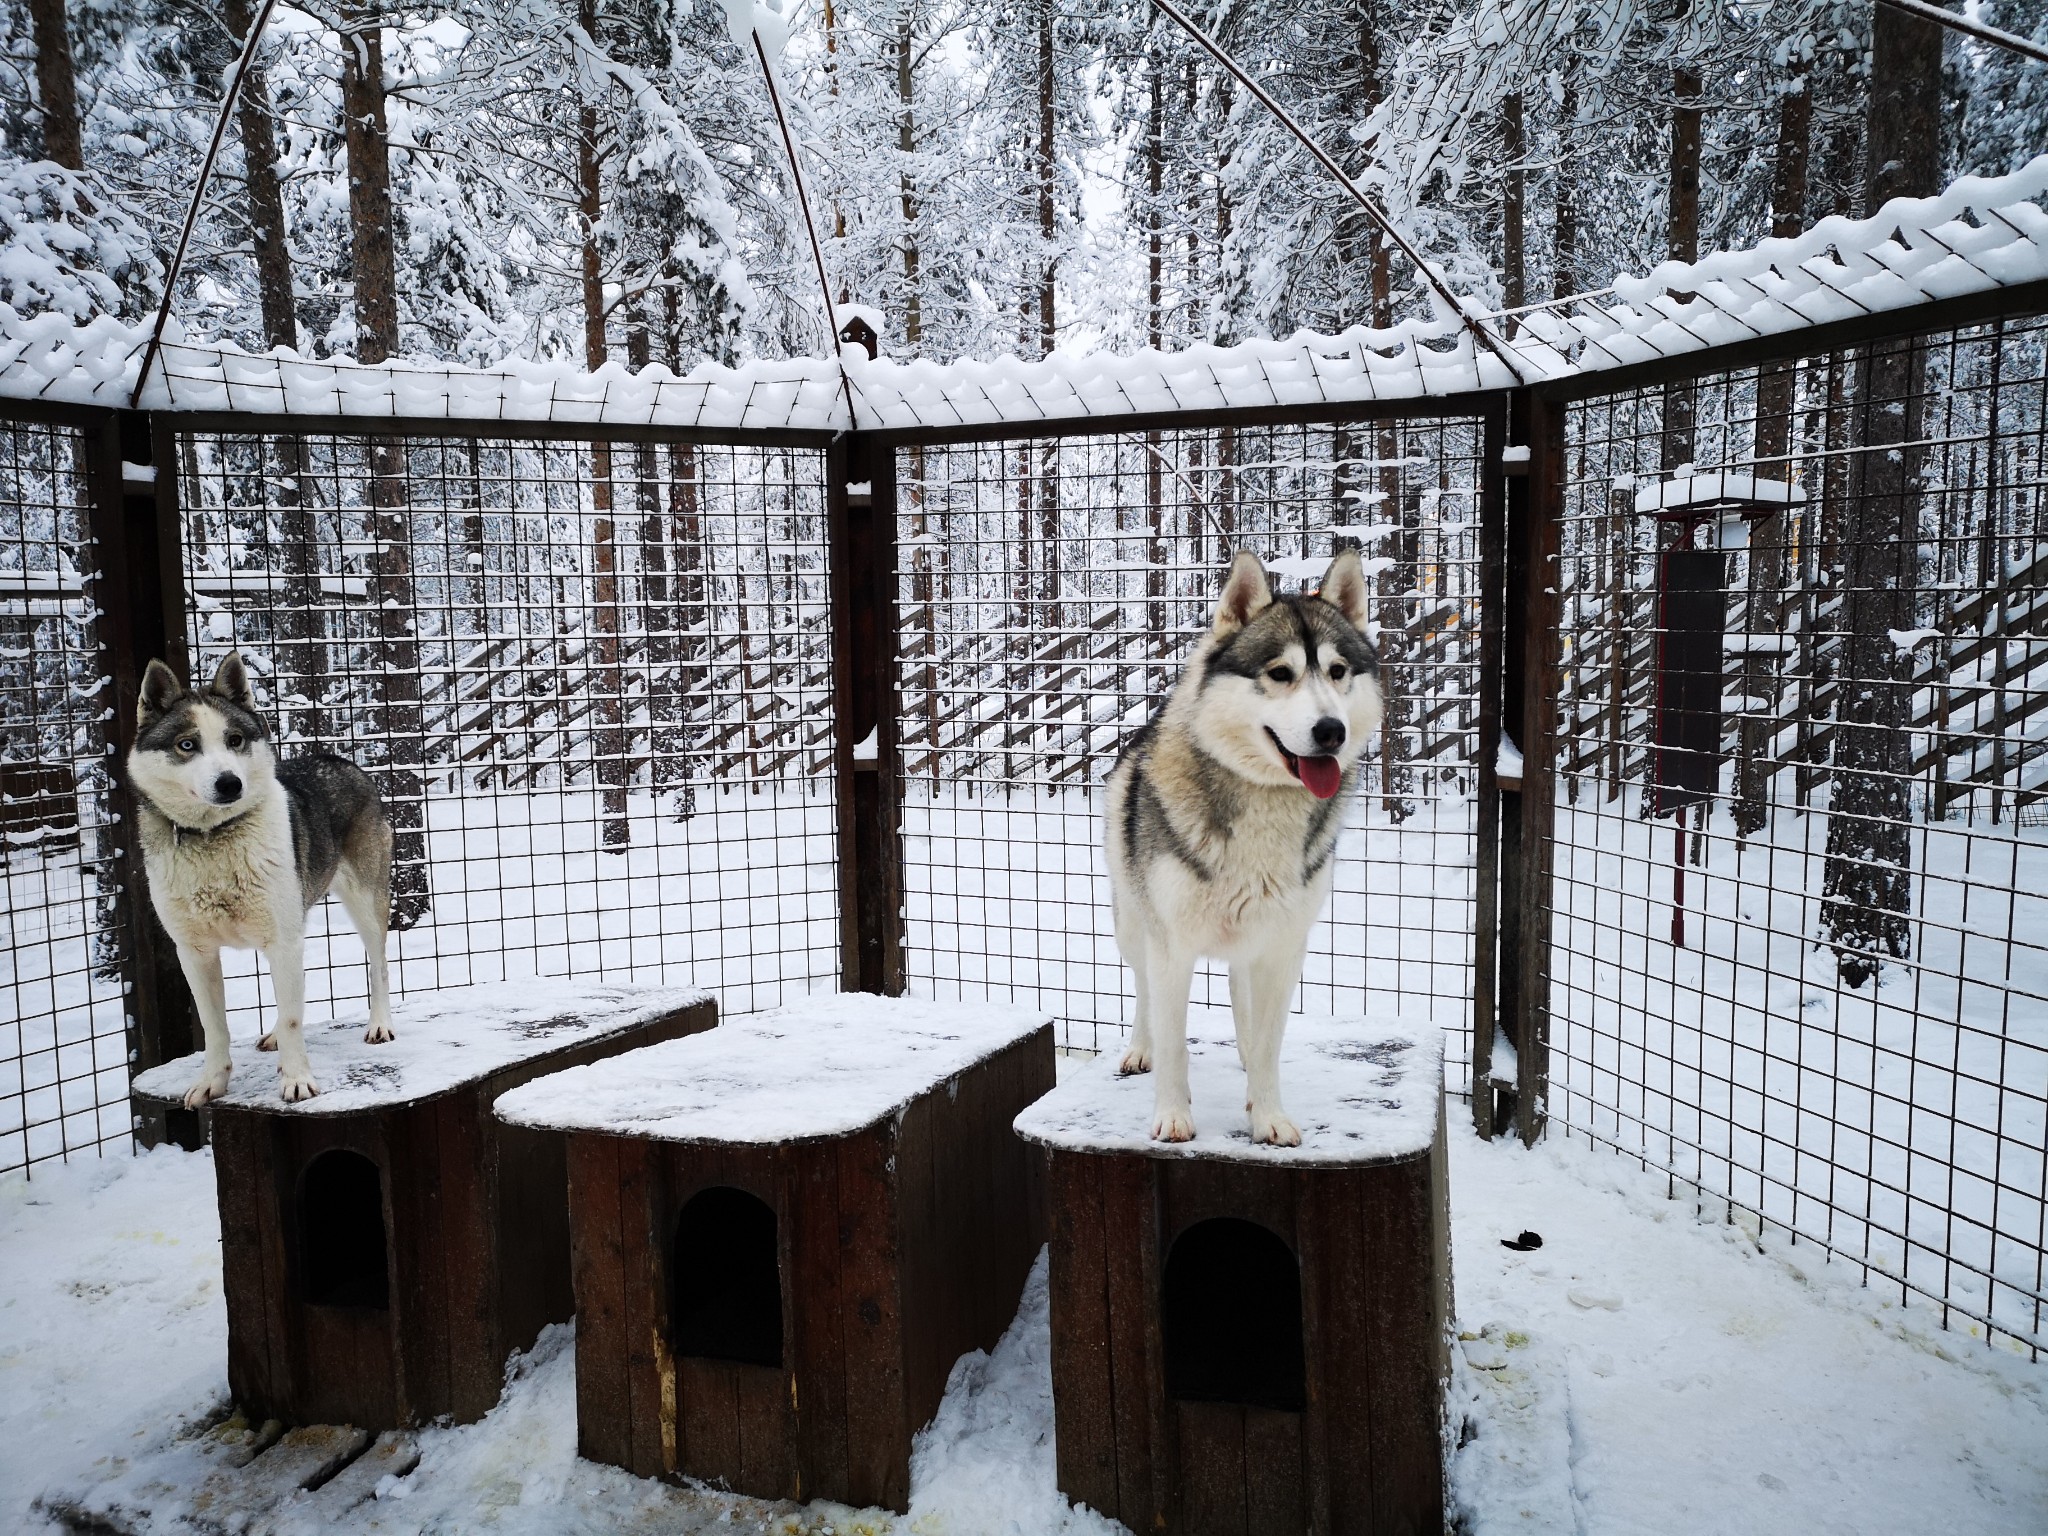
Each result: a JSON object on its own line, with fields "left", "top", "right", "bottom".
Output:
{"left": 0, "top": 156, "right": 2048, "bottom": 432}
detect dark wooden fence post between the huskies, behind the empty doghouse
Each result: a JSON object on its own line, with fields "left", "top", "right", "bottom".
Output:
{"left": 825, "top": 432, "right": 903, "bottom": 997}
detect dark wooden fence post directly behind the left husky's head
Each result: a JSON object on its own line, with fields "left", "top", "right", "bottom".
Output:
{"left": 86, "top": 412, "right": 203, "bottom": 1149}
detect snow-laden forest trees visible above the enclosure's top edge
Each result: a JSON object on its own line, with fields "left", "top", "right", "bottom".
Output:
{"left": 0, "top": 0, "right": 2048, "bottom": 373}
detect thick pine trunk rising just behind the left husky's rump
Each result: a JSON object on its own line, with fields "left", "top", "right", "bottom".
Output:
{"left": 342, "top": 4, "right": 428, "bottom": 928}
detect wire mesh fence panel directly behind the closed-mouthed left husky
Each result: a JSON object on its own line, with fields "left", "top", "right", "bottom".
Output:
{"left": 178, "top": 432, "right": 840, "bottom": 1064}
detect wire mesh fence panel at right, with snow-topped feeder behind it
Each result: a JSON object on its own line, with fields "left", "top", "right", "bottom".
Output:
{"left": 1548, "top": 319, "right": 2048, "bottom": 1356}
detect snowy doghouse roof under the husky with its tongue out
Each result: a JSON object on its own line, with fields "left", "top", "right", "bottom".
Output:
{"left": 1016, "top": 1008, "right": 1444, "bottom": 1167}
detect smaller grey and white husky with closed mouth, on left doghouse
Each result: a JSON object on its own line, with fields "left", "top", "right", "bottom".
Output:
{"left": 127, "top": 653, "right": 391, "bottom": 1110}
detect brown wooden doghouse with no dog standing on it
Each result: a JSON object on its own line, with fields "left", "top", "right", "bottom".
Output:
{"left": 498, "top": 993, "right": 1053, "bottom": 1511}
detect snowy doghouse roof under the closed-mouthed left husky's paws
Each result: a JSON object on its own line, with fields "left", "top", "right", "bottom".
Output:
{"left": 131, "top": 979, "right": 711, "bottom": 1116}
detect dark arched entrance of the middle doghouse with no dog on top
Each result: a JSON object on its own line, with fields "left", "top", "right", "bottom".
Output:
{"left": 668, "top": 1188, "right": 782, "bottom": 1366}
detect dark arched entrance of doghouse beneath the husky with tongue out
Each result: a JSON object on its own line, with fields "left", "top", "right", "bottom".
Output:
{"left": 1161, "top": 1217, "right": 1307, "bottom": 1413}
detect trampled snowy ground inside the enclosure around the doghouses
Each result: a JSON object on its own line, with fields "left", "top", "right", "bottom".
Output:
{"left": 0, "top": 1116, "right": 2048, "bottom": 1536}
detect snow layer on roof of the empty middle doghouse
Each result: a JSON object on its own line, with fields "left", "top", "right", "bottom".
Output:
{"left": 498, "top": 993, "right": 1053, "bottom": 1145}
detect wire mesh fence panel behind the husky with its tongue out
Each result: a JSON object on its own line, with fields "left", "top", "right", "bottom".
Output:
{"left": 897, "top": 418, "right": 1483, "bottom": 1073}
